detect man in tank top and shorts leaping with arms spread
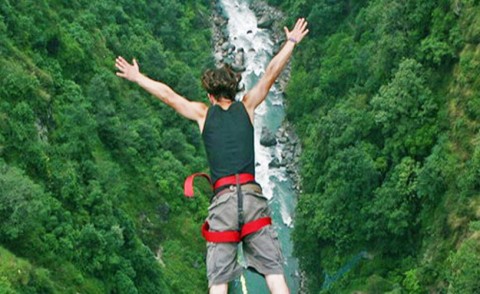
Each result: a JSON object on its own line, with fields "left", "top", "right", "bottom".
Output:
{"left": 115, "top": 18, "right": 308, "bottom": 294}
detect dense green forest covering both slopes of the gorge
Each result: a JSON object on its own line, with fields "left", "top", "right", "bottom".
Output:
{"left": 0, "top": 0, "right": 480, "bottom": 294}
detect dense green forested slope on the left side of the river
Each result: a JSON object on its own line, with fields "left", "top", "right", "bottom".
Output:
{"left": 0, "top": 0, "right": 212, "bottom": 293}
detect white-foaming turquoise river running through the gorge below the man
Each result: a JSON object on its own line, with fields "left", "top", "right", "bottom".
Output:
{"left": 219, "top": 0, "right": 300, "bottom": 294}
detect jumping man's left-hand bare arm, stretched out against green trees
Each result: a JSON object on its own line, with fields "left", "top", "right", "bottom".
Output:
{"left": 115, "top": 56, "right": 208, "bottom": 130}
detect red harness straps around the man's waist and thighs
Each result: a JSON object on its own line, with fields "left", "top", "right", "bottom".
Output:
{"left": 183, "top": 173, "right": 272, "bottom": 243}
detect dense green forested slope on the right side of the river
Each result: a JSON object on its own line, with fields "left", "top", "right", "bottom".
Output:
{"left": 269, "top": 0, "right": 480, "bottom": 293}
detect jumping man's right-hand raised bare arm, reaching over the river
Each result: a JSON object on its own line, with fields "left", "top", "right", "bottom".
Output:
{"left": 243, "top": 18, "right": 308, "bottom": 118}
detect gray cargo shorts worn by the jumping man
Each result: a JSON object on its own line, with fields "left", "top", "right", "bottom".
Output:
{"left": 207, "top": 184, "right": 283, "bottom": 287}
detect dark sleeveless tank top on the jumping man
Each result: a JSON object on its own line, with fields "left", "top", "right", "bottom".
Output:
{"left": 202, "top": 102, "right": 255, "bottom": 183}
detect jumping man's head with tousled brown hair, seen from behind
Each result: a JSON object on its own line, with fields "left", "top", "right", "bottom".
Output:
{"left": 202, "top": 64, "right": 241, "bottom": 101}
